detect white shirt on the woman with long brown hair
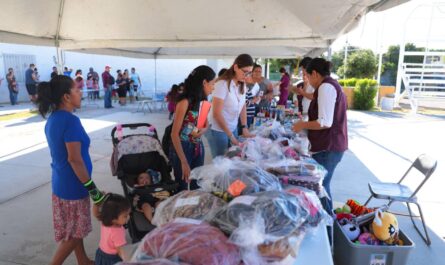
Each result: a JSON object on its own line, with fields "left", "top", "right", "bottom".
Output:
{"left": 209, "top": 80, "right": 247, "bottom": 132}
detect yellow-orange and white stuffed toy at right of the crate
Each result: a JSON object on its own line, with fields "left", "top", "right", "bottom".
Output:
{"left": 372, "top": 210, "right": 399, "bottom": 245}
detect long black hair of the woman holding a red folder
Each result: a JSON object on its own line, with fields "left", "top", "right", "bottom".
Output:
{"left": 177, "top": 65, "right": 216, "bottom": 110}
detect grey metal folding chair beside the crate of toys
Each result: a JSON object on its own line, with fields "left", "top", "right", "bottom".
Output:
{"left": 365, "top": 154, "right": 437, "bottom": 246}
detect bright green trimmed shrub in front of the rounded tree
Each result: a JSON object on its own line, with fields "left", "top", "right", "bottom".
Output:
{"left": 354, "top": 79, "right": 377, "bottom": 110}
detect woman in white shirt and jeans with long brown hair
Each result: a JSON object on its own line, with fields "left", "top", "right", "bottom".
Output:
{"left": 206, "top": 54, "right": 253, "bottom": 157}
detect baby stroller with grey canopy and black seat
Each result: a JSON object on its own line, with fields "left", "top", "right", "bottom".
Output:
{"left": 110, "top": 123, "right": 178, "bottom": 243}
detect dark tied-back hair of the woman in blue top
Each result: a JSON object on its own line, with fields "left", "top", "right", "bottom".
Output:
{"left": 36, "top": 75, "right": 74, "bottom": 118}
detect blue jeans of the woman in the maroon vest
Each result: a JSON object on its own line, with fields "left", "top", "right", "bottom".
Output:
{"left": 312, "top": 151, "right": 345, "bottom": 213}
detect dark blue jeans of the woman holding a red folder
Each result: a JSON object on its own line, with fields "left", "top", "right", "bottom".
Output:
{"left": 169, "top": 141, "right": 205, "bottom": 191}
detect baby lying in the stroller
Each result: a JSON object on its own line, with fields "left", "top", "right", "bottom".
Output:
{"left": 134, "top": 172, "right": 170, "bottom": 223}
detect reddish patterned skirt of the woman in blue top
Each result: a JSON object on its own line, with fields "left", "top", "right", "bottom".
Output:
{"left": 52, "top": 194, "right": 92, "bottom": 242}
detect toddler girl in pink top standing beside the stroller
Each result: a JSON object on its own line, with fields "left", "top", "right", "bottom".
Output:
{"left": 95, "top": 193, "right": 131, "bottom": 265}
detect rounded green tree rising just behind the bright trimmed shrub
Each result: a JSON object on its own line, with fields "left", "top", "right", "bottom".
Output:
{"left": 337, "top": 50, "right": 378, "bottom": 78}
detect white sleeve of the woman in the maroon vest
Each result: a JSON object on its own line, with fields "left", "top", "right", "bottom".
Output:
{"left": 317, "top": 83, "right": 337, "bottom": 127}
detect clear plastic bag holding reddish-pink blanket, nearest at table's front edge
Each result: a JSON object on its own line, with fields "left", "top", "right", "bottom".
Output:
{"left": 132, "top": 219, "right": 241, "bottom": 265}
